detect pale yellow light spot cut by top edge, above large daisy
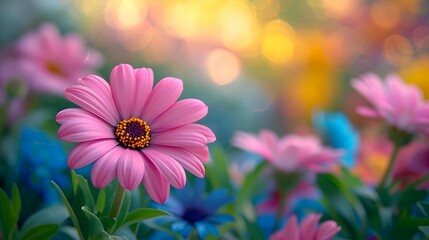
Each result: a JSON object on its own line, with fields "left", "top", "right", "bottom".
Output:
{"left": 104, "top": 0, "right": 148, "bottom": 30}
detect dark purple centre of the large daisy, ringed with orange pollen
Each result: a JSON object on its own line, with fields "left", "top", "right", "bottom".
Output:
{"left": 115, "top": 117, "right": 150, "bottom": 149}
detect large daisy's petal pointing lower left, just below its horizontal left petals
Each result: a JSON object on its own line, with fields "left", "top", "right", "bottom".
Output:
{"left": 67, "top": 139, "right": 118, "bottom": 169}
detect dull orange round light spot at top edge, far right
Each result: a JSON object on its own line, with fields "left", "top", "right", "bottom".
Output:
{"left": 370, "top": 0, "right": 401, "bottom": 29}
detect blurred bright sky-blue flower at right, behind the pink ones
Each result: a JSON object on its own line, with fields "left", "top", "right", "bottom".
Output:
{"left": 313, "top": 112, "right": 359, "bottom": 168}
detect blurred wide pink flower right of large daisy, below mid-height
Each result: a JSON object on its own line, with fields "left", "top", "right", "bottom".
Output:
{"left": 232, "top": 130, "right": 342, "bottom": 172}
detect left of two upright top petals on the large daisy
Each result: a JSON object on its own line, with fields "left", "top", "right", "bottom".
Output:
{"left": 110, "top": 64, "right": 136, "bottom": 119}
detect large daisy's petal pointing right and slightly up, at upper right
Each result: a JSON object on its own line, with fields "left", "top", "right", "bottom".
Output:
{"left": 150, "top": 99, "right": 207, "bottom": 131}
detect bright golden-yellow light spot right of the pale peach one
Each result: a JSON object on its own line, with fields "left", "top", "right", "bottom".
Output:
{"left": 262, "top": 20, "right": 295, "bottom": 64}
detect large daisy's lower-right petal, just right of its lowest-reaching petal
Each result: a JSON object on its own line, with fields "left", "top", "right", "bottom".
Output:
{"left": 142, "top": 147, "right": 186, "bottom": 188}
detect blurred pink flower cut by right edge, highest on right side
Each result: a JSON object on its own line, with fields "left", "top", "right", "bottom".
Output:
{"left": 352, "top": 73, "right": 429, "bottom": 134}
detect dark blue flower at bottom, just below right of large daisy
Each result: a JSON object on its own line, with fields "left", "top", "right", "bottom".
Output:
{"left": 154, "top": 179, "right": 233, "bottom": 239}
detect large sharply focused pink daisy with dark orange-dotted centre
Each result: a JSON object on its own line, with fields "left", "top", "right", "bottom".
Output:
{"left": 57, "top": 64, "right": 216, "bottom": 203}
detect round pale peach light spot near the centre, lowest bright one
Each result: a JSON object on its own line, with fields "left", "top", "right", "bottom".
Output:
{"left": 205, "top": 49, "right": 241, "bottom": 86}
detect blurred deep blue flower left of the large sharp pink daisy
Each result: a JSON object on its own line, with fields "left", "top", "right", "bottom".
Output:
{"left": 19, "top": 127, "right": 70, "bottom": 204}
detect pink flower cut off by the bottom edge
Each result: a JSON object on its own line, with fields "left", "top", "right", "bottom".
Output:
{"left": 270, "top": 213, "right": 341, "bottom": 240}
